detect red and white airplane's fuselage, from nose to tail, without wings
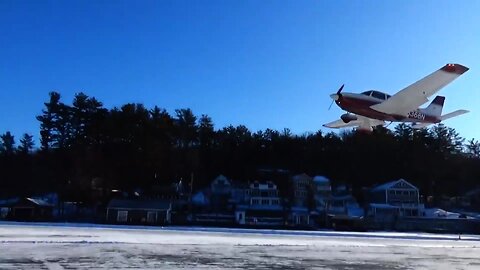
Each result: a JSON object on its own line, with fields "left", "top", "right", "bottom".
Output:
{"left": 335, "top": 93, "right": 440, "bottom": 123}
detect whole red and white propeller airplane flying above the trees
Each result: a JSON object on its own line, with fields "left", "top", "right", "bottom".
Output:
{"left": 323, "top": 64, "right": 468, "bottom": 131}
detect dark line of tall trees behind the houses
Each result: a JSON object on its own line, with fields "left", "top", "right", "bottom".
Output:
{"left": 0, "top": 92, "right": 480, "bottom": 204}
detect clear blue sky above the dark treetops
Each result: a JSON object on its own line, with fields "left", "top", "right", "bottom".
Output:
{"left": 0, "top": 0, "right": 480, "bottom": 142}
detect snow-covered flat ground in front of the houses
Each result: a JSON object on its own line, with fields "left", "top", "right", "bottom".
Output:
{"left": 0, "top": 223, "right": 480, "bottom": 269}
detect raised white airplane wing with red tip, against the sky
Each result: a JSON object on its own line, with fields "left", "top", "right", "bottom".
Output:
{"left": 370, "top": 64, "right": 468, "bottom": 116}
